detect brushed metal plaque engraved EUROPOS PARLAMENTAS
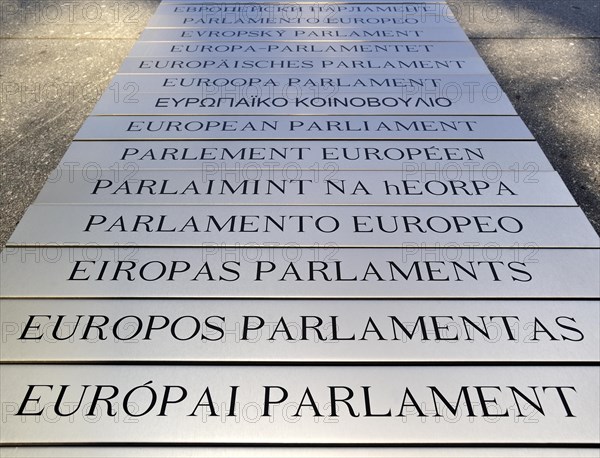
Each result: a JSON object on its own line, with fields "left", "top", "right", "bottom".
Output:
{"left": 0, "top": 299, "right": 600, "bottom": 364}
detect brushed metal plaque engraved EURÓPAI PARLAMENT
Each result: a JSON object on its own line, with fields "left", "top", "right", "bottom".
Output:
{"left": 0, "top": 364, "right": 600, "bottom": 446}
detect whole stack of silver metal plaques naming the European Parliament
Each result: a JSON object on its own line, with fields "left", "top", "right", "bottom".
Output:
{"left": 0, "top": 0, "right": 600, "bottom": 457}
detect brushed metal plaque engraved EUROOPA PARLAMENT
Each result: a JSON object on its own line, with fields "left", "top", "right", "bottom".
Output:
{"left": 105, "top": 73, "right": 502, "bottom": 95}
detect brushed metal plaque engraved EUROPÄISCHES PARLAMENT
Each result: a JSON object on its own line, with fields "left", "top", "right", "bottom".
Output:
{"left": 119, "top": 55, "right": 489, "bottom": 76}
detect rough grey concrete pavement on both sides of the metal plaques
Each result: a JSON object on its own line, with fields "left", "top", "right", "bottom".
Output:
{"left": 0, "top": 0, "right": 600, "bottom": 245}
